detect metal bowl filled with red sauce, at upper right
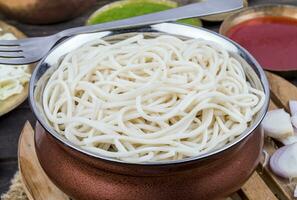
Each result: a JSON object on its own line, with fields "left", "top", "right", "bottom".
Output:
{"left": 220, "top": 5, "right": 297, "bottom": 71}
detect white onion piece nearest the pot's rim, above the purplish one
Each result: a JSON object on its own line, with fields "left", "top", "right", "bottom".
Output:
{"left": 262, "top": 109, "right": 294, "bottom": 139}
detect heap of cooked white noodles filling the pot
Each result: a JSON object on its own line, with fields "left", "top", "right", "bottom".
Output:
{"left": 42, "top": 35, "right": 265, "bottom": 162}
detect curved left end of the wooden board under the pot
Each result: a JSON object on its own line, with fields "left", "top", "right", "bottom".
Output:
{"left": 18, "top": 121, "right": 69, "bottom": 200}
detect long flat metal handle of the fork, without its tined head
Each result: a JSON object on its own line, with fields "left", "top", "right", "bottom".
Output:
{"left": 57, "top": 0, "right": 242, "bottom": 38}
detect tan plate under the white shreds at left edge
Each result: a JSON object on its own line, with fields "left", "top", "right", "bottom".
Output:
{"left": 0, "top": 21, "right": 34, "bottom": 116}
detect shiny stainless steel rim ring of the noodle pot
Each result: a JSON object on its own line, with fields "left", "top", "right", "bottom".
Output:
{"left": 29, "top": 23, "right": 269, "bottom": 166}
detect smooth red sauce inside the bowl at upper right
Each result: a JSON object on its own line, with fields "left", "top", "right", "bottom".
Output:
{"left": 227, "top": 17, "right": 297, "bottom": 71}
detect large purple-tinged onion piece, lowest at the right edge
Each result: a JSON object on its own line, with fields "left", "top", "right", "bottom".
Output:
{"left": 269, "top": 143, "right": 297, "bottom": 179}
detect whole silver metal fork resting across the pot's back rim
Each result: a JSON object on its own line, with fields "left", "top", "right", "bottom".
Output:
{"left": 0, "top": 0, "right": 242, "bottom": 65}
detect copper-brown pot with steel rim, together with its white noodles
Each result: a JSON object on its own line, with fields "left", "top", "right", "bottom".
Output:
{"left": 30, "top": 23, "right": 269, "bottom": 200}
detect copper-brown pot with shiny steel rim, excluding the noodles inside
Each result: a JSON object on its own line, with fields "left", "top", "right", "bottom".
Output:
{"left": 30, "top": 23, "right": 269, "bottom": 200}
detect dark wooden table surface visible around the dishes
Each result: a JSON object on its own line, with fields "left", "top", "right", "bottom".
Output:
{"left": 0, "top": 0, "right": 297, "bottom": 194}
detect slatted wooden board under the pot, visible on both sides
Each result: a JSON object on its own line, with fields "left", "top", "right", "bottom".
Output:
{"left": 18, "top": 72, "right": 297, "bottom": 200}
